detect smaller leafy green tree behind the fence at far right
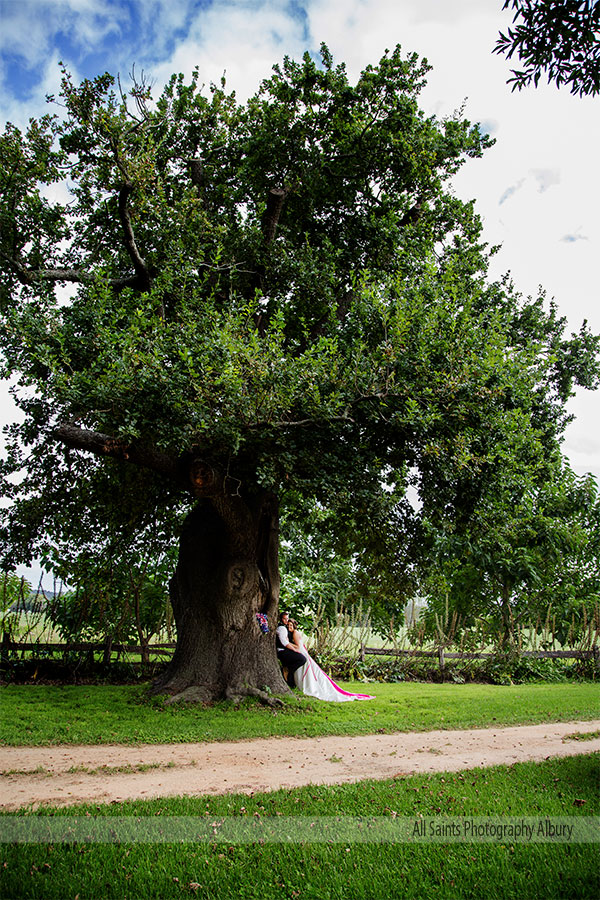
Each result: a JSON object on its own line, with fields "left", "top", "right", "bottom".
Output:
{"left": 422, "top": 460, "right": 600, "bottom": 643}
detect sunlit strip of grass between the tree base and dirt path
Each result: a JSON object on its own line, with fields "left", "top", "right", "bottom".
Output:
{"left": 0, "top": 682, "right": 600, "bottom": 746}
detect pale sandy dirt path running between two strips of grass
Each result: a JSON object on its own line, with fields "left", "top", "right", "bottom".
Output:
{"left": 0, "top": 720, "right": 600, "bottom": 810}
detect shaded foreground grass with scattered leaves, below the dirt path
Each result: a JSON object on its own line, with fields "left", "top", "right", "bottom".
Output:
{"left": 0, "top": 754, "right": 600, "bottom": 900}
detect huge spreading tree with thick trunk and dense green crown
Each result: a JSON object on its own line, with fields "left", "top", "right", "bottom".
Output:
{"left": 0, "top": 48, "right": 595, "bottom": 699}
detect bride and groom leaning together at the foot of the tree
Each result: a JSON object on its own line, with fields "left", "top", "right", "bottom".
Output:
{"left": 275, "top": 612, "right": 373, "bottom": 702}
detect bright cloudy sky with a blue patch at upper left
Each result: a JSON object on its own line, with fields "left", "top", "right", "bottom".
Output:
{"left": 0, "top": 0, "right": 600, "bottom": 588}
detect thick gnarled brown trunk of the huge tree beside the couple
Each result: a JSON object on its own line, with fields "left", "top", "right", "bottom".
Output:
{"left": 153, "top": 482, "right": 289, "bottom": 702}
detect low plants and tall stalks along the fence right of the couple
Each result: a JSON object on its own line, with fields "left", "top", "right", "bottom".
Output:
{"left": 309, "top": 600, "right": 600, "bottom": 684}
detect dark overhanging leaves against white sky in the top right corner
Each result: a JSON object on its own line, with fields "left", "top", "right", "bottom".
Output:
{"left": 495, "top": 0, "right": 600, "bottom": 96}
